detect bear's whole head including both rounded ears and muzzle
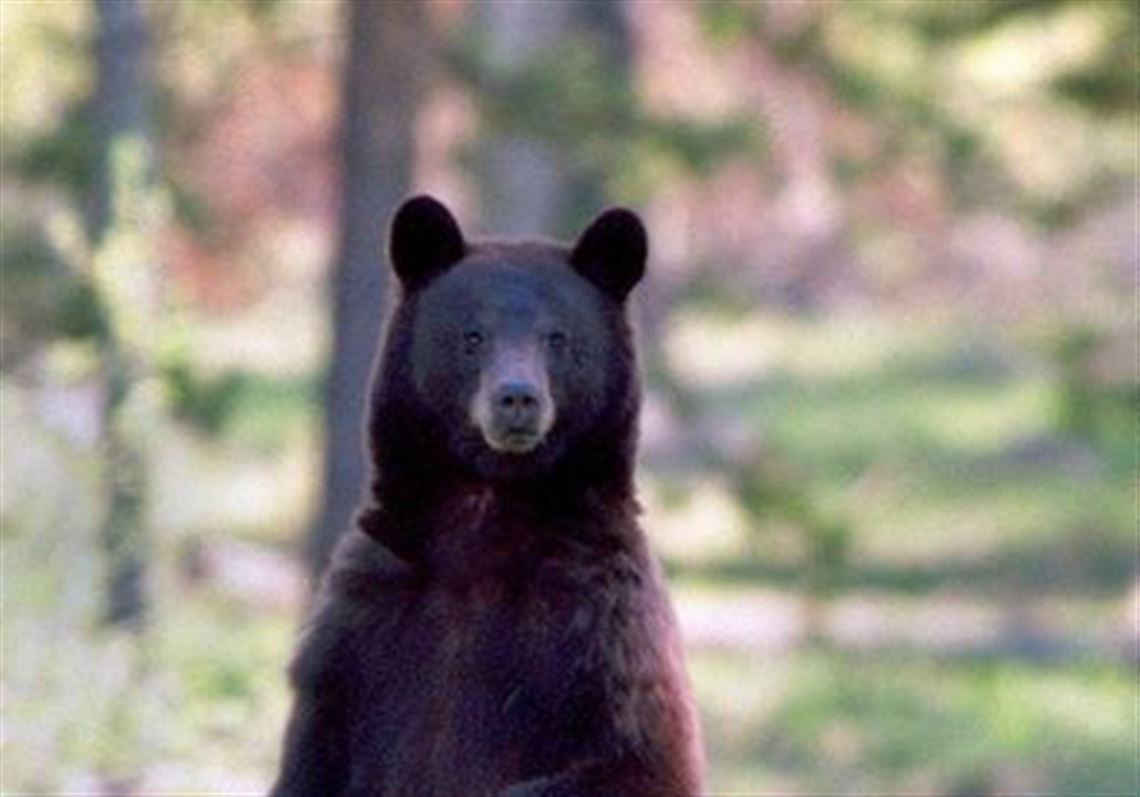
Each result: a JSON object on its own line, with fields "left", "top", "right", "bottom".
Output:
{"left": 372, "top": 197, "right": 648, "bottom": 482}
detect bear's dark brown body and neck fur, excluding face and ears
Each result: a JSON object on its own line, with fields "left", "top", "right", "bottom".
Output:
{"left": 271, "top": 196, "right": 701, "bottom": 797}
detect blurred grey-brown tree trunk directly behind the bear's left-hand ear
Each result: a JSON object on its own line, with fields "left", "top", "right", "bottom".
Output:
{"left": 306, "top": 2, "right": 432, "bottom": 578}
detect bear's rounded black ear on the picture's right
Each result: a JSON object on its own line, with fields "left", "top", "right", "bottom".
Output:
{"left": 570, "top": 208, "right": 649, "bottom": 302}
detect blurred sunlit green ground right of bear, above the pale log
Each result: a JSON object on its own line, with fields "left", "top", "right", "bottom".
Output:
{"left": 676, "top": 319, "right": 1138, "bottom": 597}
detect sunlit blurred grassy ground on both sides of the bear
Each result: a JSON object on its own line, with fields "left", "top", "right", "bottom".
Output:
{"left": 2, "top": 303, "right": 1137, "bottom": 797}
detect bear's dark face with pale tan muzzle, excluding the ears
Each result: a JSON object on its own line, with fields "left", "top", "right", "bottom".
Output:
{"left": 409, "top": 247, "right": 626, "bottom": 479}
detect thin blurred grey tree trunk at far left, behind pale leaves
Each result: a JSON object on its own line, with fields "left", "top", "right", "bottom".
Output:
{"left": 88, "top": 0, "right": 158, "bottom": 628}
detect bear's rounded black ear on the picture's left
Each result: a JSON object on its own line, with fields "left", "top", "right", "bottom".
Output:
{"left": 389, "top": 195, "right": 466, "bottom": 290}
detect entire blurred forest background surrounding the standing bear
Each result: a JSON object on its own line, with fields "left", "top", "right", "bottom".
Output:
{"left": 0, "top": 0, "right": 1140, "bottom": 797}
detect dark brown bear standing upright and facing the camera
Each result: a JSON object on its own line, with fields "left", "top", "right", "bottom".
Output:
{"left": 270, "top": 196, "right": 703, "bottom": 797}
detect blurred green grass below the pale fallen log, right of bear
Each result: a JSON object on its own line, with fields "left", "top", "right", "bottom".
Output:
{"left": 691, "top": 648, "right": 1134, "bottom": 797}
